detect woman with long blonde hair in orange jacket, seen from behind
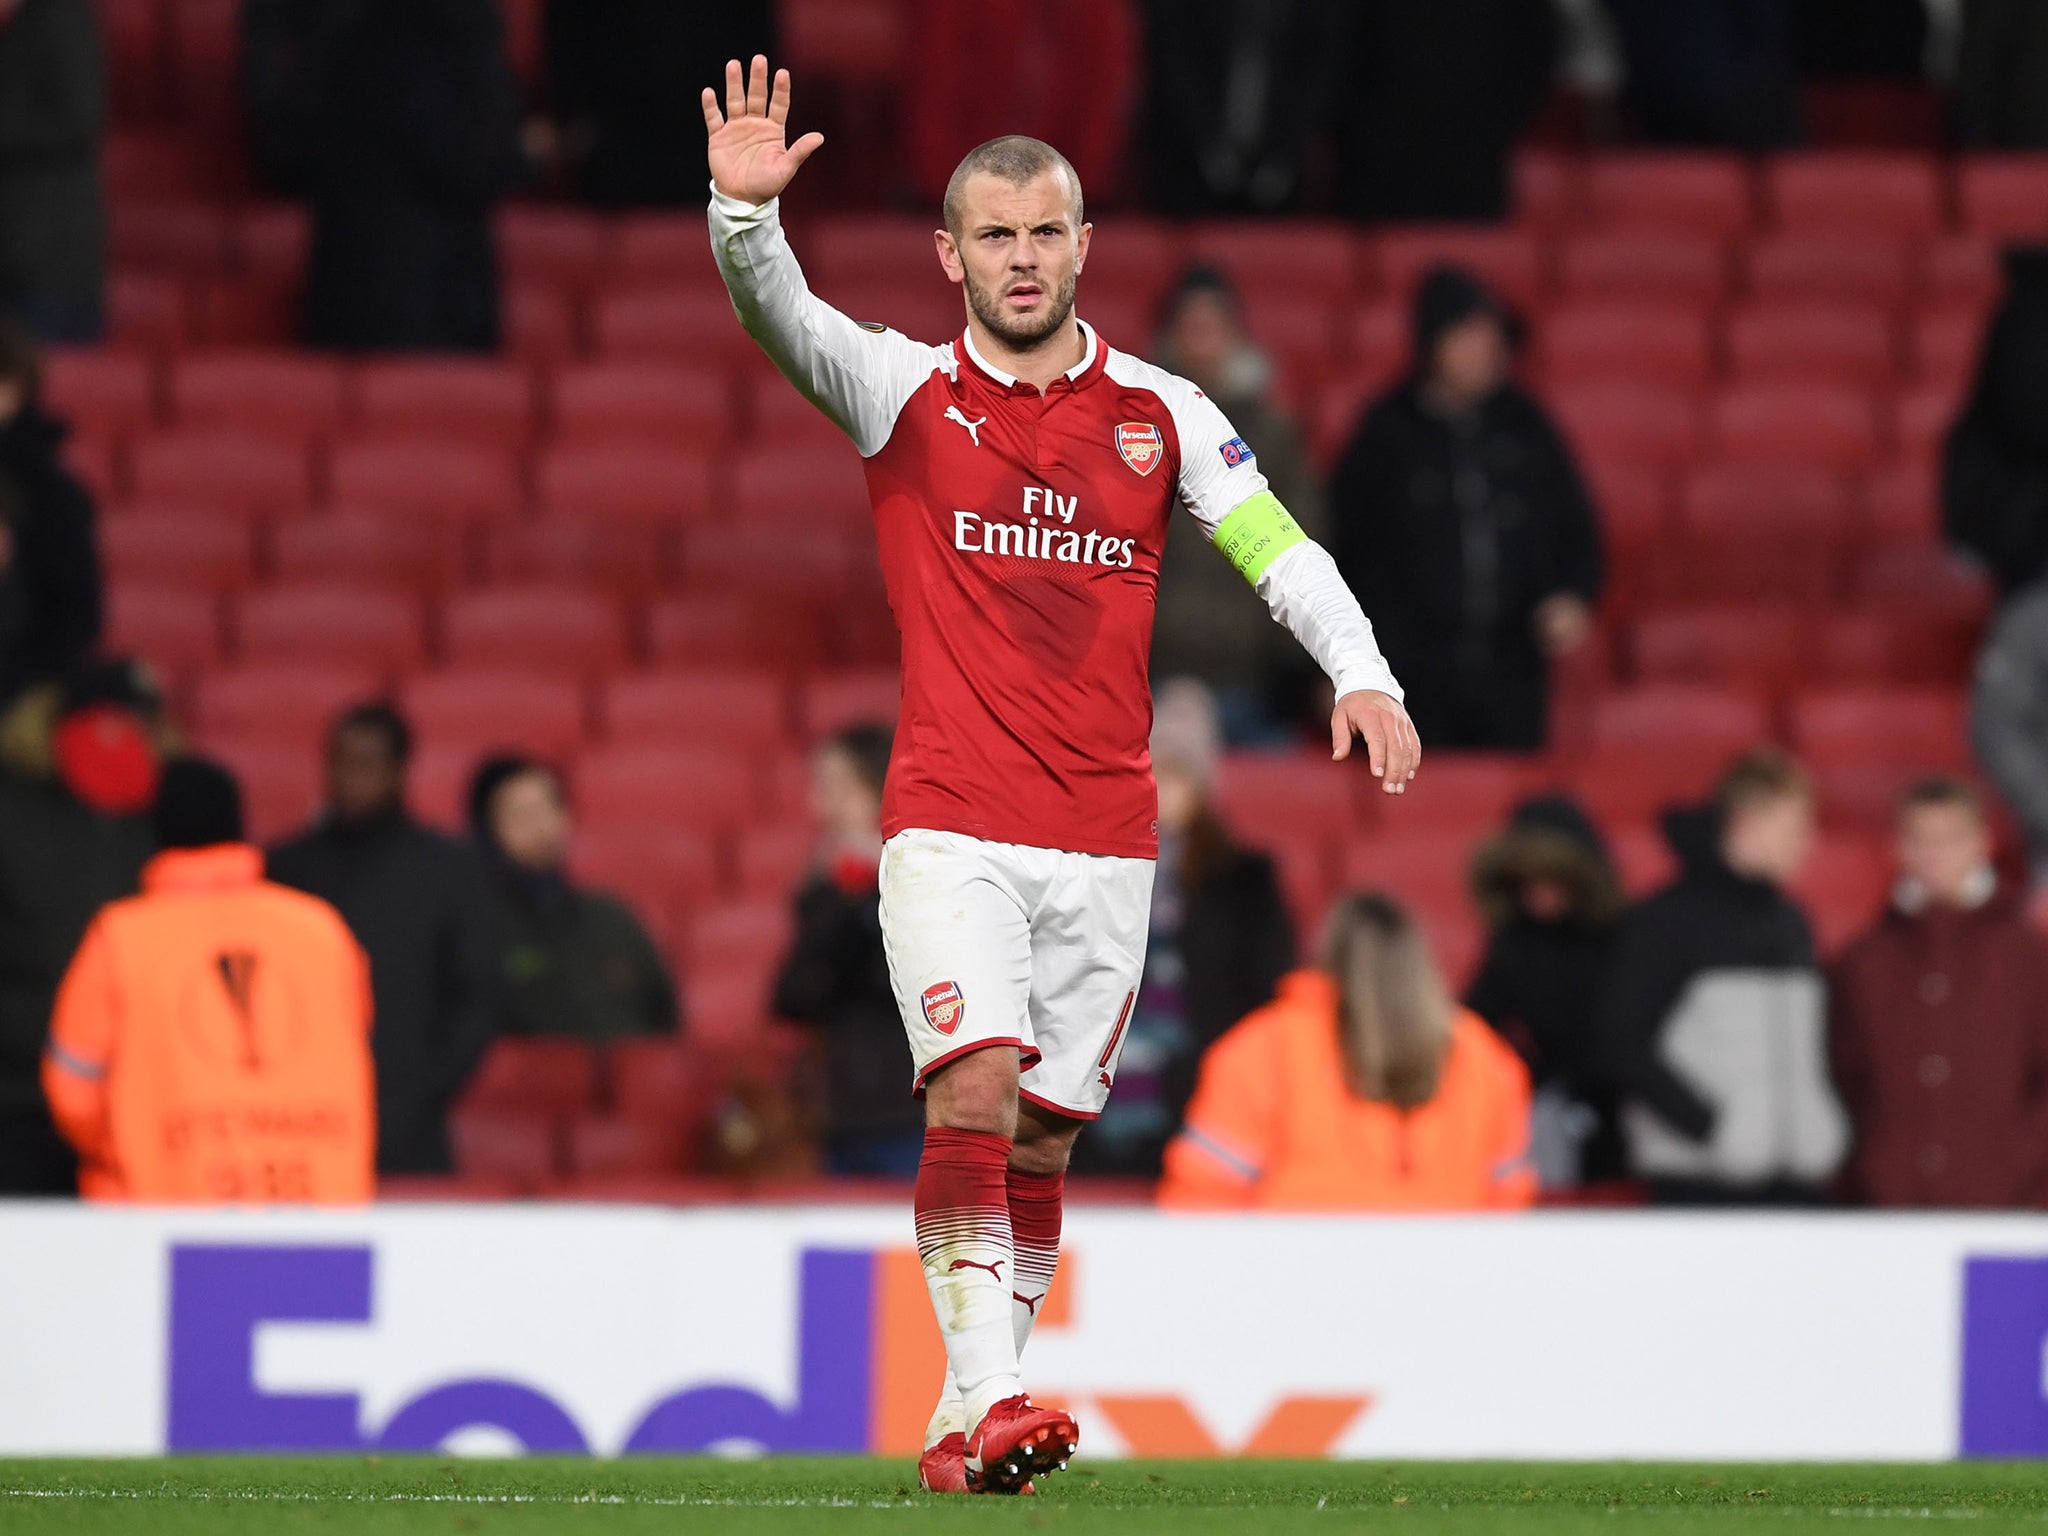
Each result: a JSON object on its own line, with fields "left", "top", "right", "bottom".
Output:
{"left": 1159, "top": 893, "right": 1536, "bottom": 1210}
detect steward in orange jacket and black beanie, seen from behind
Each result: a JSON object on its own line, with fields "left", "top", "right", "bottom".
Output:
{"left": 43, "top": 760, "right": 377, "bottom": 1204}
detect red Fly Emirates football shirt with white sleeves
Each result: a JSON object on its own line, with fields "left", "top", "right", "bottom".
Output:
{"left": 711, "top": 197, "right": 1399, "bottom": 858}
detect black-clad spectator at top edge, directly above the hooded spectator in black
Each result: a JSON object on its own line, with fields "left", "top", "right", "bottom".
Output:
{"left": 1335, "top": 0, "right": 1561, "bottom": 219}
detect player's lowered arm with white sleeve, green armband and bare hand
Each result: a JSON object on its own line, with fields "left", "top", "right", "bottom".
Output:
{"left": 1171, "top": 383, "right": 1421, "bottom": 795}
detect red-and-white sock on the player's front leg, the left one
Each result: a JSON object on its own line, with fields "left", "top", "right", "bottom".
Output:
{"left": 915, "top": 1126, "right": 1024, "bottom": 1430}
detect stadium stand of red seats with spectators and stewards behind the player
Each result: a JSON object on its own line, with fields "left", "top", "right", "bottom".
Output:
{"left": 0, "top": 0, "right": 2048, "bottom": 1208}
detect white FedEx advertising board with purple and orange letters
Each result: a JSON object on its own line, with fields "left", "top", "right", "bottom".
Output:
{"left": 0, "top": 1204, "right": 2048, "bottom": 1460}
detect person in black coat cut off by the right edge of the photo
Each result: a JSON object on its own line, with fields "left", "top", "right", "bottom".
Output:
{"left": 1942, "top": 250, "right": 2048, "bottom": 596}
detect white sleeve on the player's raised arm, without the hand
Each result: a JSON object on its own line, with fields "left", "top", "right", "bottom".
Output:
{"left": 711, "top": 186, "right": 938, "bottom": 459}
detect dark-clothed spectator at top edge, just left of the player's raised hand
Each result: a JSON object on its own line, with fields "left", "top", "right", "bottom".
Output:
{"left": 543, "top": 0, "right": 780, "bottom": 208}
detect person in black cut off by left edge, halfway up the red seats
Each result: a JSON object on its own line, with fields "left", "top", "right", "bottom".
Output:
{"left": 0, "top": 319, "right": 102, "bottom": 709}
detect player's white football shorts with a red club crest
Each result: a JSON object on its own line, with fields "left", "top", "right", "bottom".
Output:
{"left": 881, "top": 827, "right": 1153, "bottom": 1120}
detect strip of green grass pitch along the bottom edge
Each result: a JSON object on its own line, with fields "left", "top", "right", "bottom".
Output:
{"left": 0, "top": 1456, "right": 2048, "bottom": 1536}
